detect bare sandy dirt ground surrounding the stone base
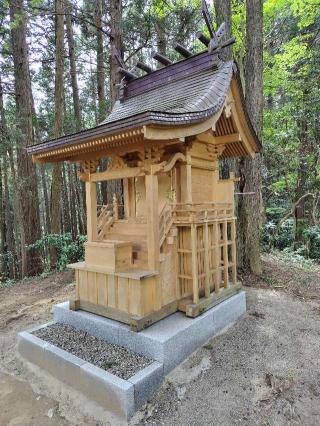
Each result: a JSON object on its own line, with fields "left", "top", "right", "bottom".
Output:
{"left": 0, "top": 254, "right": 320, "bottom": 426}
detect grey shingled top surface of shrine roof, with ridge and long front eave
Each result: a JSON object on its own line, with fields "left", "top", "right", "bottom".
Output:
{"left": 28, "top": 52, "right": 260, "bottom": 161}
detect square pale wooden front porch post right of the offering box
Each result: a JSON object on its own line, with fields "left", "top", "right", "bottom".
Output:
{"left": 145, "top": 174, "right": 160, "bottom": 270}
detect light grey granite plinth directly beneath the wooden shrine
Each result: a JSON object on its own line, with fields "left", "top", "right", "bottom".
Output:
{"left": 54, "top": 291, "right": 246, "bottom": 374}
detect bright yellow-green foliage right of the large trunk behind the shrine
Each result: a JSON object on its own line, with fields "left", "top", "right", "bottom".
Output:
{"left": 263, "top": 0, "right": 320, "bottom": 206}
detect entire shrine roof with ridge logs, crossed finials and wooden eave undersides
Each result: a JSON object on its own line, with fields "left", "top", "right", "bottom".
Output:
{"left": 27, "top": 0, "right": 261, "bottom": 162}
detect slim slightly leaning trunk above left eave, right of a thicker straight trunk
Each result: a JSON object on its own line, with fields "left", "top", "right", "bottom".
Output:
{"left": 66, "top": 0, "right": 82, "bottom": 132}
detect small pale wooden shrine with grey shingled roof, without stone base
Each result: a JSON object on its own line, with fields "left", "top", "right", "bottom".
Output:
{"left": 28, "top": 2, "right": 260, "bottom": 330}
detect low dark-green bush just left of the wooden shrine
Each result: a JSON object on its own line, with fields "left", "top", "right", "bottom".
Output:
{"left": 28, "top": 233, "right": 86, "bottom": 271}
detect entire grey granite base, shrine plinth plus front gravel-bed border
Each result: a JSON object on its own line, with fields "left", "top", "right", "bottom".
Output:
{"left": 18, "top": 291, "right": 246, "bottom": 419}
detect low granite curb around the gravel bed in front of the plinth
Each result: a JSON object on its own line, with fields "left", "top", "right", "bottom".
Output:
{"left": 18, "top": 326, "right": 163, "bottom": 420}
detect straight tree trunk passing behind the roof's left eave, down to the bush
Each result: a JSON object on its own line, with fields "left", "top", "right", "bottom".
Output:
{"left": 51, "top": 0, "right": 64, "bottom": 267}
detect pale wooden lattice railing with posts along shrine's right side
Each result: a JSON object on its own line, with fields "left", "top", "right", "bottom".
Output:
{"left": 174, "top": 203, "right": 237, "bottom": 304}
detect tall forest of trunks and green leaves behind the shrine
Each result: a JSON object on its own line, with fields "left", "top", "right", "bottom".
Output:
{"left": 0, "top": 0, "right": 320, "bottom": 284}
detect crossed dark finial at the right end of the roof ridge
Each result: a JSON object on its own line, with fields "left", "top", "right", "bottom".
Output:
{"left": 196, "top": 0, "right": 236, "bottom": 53}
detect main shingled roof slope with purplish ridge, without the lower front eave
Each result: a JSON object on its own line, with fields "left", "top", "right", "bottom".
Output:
{"left": 102, "top": 52, "right": 234, "bottom": 125}
